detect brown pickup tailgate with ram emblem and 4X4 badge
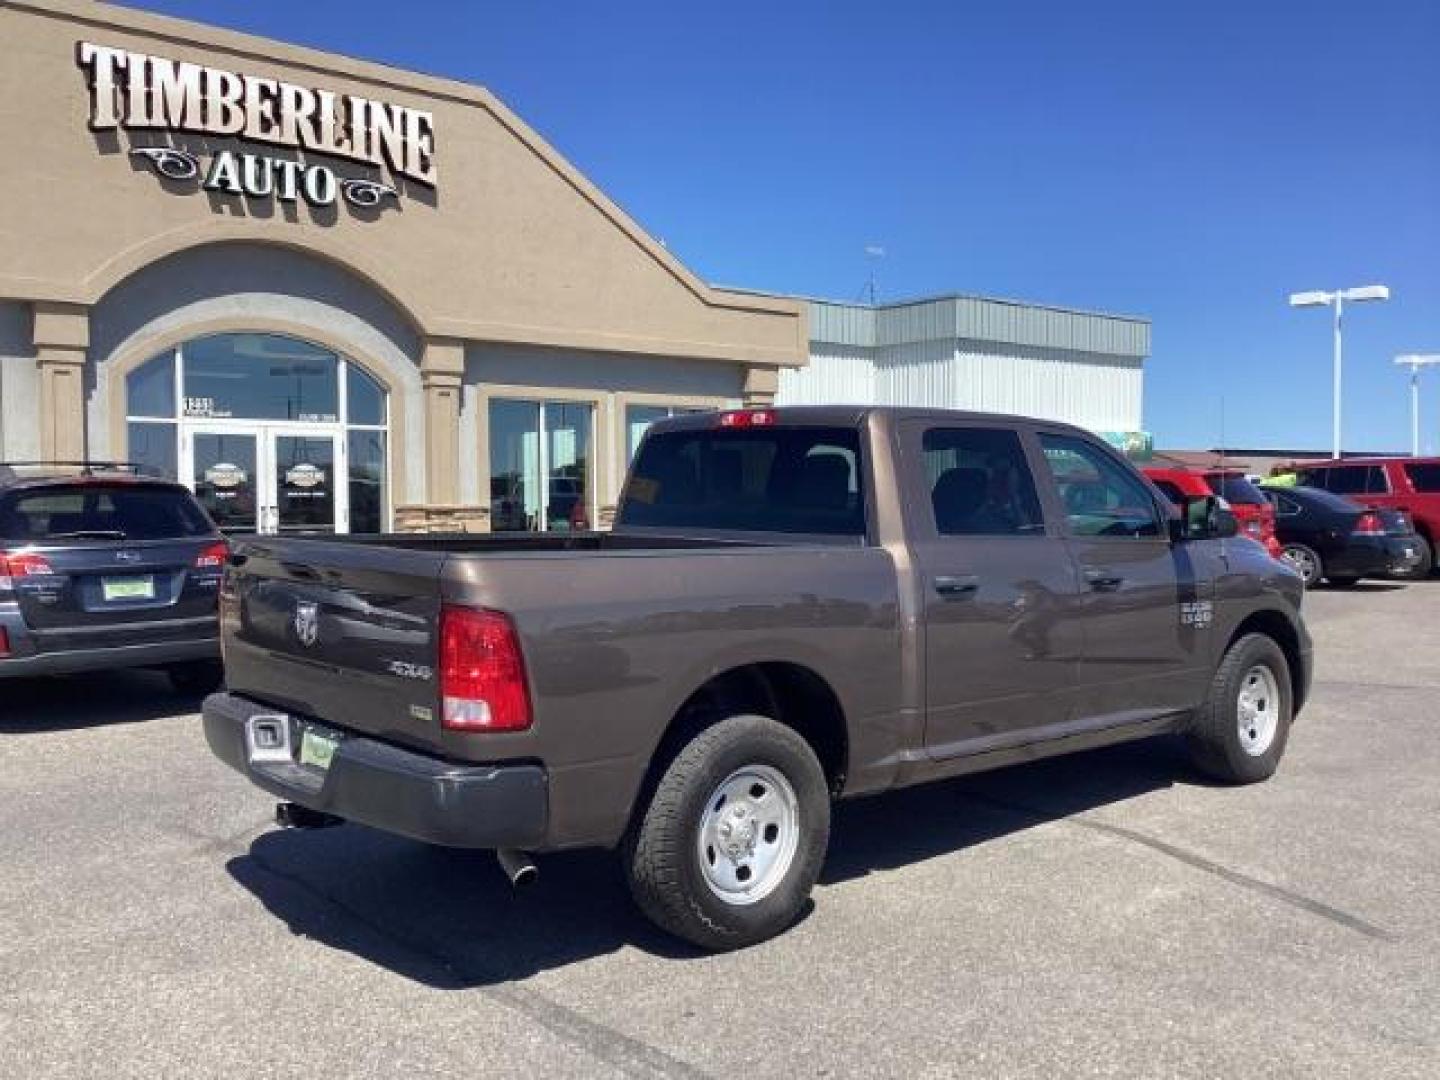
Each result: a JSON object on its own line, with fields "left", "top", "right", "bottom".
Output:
{"left": 222, "top": 539, "right": 448, "bottom": 750}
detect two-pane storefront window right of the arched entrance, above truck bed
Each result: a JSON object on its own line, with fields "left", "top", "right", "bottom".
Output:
{"left": 490, "top": 399, "right": 595, "bottom": 533}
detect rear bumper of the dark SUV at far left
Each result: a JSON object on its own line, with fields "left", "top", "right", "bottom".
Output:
{"left": 0, "top": 605, "right": 220, "bottom": 678}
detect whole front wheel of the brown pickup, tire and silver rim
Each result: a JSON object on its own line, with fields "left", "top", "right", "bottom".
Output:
{"left": 1187, "top": 634, "right": 1295, "bottom": 783}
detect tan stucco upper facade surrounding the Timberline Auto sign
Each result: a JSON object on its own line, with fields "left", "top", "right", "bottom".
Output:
{"left": 0, "top": 0, "right": 805, "bottom": 364}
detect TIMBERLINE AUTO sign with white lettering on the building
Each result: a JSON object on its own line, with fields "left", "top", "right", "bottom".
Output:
{"left": 76, "top": 42, "right": 435, "bottom": 207}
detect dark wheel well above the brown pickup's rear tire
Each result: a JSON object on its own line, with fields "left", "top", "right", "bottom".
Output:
{"left": 651, "top": 662, "right": 850, "bottom": 795}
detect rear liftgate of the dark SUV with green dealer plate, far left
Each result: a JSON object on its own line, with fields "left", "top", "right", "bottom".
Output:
{"left": 0, "top": 481, "right": 223, "bottom": 648}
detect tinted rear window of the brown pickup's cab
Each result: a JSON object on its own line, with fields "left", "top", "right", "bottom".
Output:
{"left": 616, "top": 428, "right": 865, "bottom": 536}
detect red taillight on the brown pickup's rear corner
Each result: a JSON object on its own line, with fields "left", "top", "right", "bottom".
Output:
{"left": 441, "top": 605, "right": 531, "bottom": 732}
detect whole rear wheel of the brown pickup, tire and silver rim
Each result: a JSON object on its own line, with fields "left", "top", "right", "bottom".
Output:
{"left": 624, "top": 716, "right": 829, "bottom": 949}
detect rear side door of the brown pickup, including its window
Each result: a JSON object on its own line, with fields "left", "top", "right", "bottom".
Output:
{"left": 901, "top": 420, "right": 1081, "bottom": 757}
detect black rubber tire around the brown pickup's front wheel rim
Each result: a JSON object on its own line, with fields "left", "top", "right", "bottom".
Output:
{"left": 1187, "top": 634, "right": 1295, "bottom": 783}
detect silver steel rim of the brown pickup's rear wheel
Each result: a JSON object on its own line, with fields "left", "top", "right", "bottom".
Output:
{"left": 696, "top": 765, "right": 801, "bottom": 904}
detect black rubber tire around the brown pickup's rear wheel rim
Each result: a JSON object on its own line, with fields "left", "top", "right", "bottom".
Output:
{"left": 622, "top": 716, "right": 829, "bottom": 950}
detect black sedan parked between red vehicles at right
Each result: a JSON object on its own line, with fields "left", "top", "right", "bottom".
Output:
{"left": 1263, "top": 487, "right": 1423, "bottom": 586}
